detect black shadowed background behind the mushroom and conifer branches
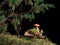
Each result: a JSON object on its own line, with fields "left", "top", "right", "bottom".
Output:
{"left": 0, "top": 0, "right": 60, "bottom": 45}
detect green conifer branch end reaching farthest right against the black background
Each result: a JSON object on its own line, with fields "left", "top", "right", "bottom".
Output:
{"left": 34, "top": 3, "right": 54, "bottom": 13}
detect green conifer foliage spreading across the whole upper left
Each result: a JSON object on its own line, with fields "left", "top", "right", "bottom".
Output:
{"left": 0, "top": 0, "right": 54, "bottom": 35}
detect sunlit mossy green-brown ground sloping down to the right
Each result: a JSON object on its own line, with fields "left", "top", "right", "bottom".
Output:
{"left": 0, "top": 34, "right": 57, "bottom": 45}
